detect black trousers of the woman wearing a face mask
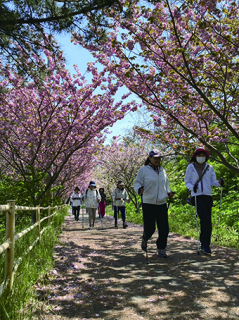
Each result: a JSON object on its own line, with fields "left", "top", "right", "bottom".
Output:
{"left": 194, "top": 195, "right": 213, "bottom": 246}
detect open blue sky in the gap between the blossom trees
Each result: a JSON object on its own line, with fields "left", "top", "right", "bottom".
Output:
{"left": 56, "top": 34, "right": 136, "bottom": 141}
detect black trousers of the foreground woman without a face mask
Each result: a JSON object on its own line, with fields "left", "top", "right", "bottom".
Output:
{"left": 142, "top": 203, "right": 169, "bottom": 249}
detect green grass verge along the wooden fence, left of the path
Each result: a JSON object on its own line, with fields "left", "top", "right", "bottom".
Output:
{"left": 0, "top": 209, "right": 68, "bottom": 320}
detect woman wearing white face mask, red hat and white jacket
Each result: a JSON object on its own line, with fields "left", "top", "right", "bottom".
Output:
{"left": 184, "top": 148, "right": 223, "bottom": 254}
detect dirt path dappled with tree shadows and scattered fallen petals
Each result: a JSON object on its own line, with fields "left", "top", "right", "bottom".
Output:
{"left": 33, "top": 209, "right": 239, "bottom": 320}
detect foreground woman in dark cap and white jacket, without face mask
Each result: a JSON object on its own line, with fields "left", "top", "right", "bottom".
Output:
{"left": 134, "top": 150, "right": 173, "bottom": 258}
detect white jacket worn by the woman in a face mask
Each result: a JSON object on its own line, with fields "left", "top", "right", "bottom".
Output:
{"left": 184, "top": 163, "right": 220, "bottom": 196}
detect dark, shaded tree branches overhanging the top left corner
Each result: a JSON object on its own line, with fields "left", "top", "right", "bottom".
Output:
{"left": 0, "top": 0, "right": 120, "bottom": 67}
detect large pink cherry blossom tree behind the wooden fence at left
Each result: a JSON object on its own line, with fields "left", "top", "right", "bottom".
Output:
{"left": 0, "top": 37, "right": 136, "bottom": 204}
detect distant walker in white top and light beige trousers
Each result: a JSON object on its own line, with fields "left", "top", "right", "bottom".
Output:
{"left": 83, "top": 181, "right": 101, "bottom": 229}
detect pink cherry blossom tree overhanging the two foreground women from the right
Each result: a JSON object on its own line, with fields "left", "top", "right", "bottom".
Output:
{"left": 75, "top": 0, "right": 239, "bottom": 174}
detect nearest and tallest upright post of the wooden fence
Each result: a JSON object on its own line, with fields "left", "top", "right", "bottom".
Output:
{"left": 5, "top": 200, "right": 15, "bottom": 291}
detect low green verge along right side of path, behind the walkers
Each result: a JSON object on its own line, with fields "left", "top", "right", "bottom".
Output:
{"left": 106, "top": 200, "right": 239, "bottom": 249}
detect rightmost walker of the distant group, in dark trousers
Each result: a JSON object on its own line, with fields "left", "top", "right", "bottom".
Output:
{"left": 112, "top": 180, "right": 129, "bottom": 229}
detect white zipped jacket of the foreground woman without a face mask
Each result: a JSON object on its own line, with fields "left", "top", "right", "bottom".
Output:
{"left": 134, "top": 165, "right": 171, "bottom": 205}
